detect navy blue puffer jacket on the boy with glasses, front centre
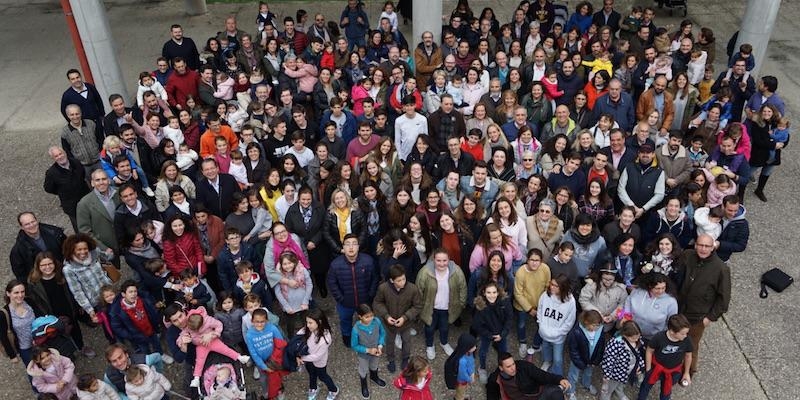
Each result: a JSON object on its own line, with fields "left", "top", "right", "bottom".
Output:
{"left": 328, "top": 253, "right": 379, "bottom": 308}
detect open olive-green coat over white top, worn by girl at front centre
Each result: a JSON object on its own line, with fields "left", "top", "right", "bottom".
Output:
{"left": 417, "top": 260, "right": 467, "bottom": 325}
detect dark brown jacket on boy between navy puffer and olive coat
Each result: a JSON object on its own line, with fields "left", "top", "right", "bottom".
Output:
{"left": 372, "top": 280, "right": 422, "bottom": 332}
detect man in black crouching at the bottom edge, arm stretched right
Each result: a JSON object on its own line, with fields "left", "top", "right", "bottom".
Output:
{"left": 486, "top": 352, "right": 570, "bottom": 400}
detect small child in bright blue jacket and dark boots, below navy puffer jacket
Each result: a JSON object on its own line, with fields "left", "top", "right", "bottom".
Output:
{"left": 350, "top": 304, "right": 386, "bottom": 399}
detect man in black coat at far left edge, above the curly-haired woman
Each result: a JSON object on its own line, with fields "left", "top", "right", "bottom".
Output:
{"left": 8, "top": 211, "right": 67, "bottom": 282}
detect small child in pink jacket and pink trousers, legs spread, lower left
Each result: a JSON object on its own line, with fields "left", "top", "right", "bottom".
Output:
{"left": 176, "top": 306, "right": 250, "bottom": 387}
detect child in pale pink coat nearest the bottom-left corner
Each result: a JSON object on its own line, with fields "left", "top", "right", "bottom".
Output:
{"left": 27, "top": 347, "right": 77, "bottom": 400}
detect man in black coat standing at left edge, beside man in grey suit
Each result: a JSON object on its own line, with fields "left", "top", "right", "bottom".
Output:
{"left": 44, "top": 146, "right": 90, "bottom": 232}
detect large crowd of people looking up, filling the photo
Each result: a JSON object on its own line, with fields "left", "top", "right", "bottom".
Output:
{"left": 0, "top": 0, "right": 790, "bottom": 400}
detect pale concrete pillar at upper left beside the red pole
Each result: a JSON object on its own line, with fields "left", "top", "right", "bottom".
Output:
{"left": 69, "top": 0, "right": 129, "bottom": 110}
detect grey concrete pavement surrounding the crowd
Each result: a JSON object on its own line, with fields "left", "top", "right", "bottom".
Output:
{"left": 0, "top": 0, "right": 800, "bottom": 400}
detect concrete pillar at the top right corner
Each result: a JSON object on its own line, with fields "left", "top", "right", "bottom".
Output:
{"left": 734, "top": 0, "right": 781, "bottom": 76}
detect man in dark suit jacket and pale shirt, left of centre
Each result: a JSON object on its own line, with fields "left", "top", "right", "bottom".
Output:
{"left": 197, "top": 158, "right": 240, "bottom": 221}
